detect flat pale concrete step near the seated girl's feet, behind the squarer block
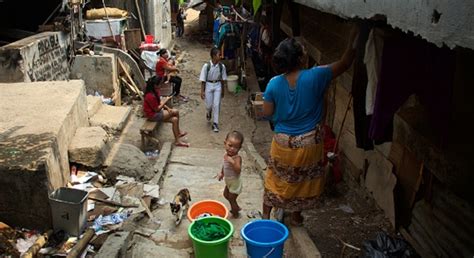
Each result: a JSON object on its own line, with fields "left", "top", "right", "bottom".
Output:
{"left": 89, "top": 104, "right": 132, "bottom": 134}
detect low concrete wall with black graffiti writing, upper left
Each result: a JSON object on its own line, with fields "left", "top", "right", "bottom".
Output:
{"left": 0, "top": 32, "right": 69, "bottom": 82}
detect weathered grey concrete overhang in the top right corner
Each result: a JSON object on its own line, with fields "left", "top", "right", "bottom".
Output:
{"left": 296, "top": 0, "right": 474, "bottom": 49}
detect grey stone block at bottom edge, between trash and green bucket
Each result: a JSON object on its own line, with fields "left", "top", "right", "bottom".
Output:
{"left": 94, "top": 232, "right": 132, "bottom": 258}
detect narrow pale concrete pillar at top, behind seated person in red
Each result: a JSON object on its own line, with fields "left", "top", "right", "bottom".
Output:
{"left": 145, "top": 0, "right": 172, "bottom": 48}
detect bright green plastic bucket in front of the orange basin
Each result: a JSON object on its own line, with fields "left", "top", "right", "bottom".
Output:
{"left": 188, "top": 216, "right": 234, "bottom": 258}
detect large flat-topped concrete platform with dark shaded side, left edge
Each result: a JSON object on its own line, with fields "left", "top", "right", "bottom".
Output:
{"left": 0, "top": 80, "right": 89, "bottom": 228}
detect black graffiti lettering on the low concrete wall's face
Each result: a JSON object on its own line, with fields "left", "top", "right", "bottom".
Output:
{"left": 25, "top": 34, "right": 69, "bottom": 82}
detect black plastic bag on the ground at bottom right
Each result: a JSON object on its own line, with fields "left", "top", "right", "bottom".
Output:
{"left": 362, "top": 232, "right": 418, "bottom": 258}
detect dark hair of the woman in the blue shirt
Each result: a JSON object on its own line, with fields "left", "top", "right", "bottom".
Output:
{"left": 272, "top": 38, "right": 304, "bottom": 74}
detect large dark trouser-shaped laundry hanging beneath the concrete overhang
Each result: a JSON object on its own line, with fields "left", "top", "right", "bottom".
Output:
{"left": 369, "top": 36, "right": 455, "bottom": 143}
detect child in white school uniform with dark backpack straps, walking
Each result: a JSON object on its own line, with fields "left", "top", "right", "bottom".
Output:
{"left": 199, "top": 47, "right": 227, "bottom": 133}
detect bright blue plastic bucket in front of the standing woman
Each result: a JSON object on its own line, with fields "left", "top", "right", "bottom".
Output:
{"left": 240, "top": 220, "right": 289, "bottom": 258}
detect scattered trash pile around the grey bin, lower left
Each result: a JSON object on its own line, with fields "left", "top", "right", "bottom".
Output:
{"left": 0, "top": 166, "right": 164, "bottom": 257}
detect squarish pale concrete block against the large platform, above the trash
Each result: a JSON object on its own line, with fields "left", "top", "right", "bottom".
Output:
{"left": 69, "top": 126, "right": 109, "bottom": 167}
